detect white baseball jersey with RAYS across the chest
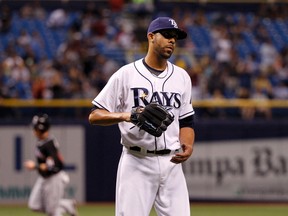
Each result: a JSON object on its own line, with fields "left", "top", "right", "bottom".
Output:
{"left": 92, "top": 59, "right": 194, "bottom": 150}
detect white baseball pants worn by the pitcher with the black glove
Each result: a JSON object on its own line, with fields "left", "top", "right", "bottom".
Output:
{"left": 115, "top": 147, "right": 190, "bottom": 216}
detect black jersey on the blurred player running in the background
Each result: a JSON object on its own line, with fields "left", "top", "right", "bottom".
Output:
{"left": 36, "top": 138, "right": 64, "bottom": 178}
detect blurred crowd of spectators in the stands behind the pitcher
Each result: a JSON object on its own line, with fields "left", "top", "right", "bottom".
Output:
{"left": 0, "top": 2, "right": 288, "bottom": 118}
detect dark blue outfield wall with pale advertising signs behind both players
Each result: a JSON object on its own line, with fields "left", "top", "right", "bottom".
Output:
{"left": 0, "top": 119, "right": 288, "bottom": 203}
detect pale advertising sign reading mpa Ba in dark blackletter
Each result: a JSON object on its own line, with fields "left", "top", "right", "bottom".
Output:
{"left": 183, "top": 138, "right": 288, "bottom": 201}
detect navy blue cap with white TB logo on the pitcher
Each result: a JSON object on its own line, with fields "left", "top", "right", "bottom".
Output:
{"left": 147, "top": 17, "right": 187, "bottom": 40}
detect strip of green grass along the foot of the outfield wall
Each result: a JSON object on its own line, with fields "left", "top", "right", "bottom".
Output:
{"left": 0, "top": 203, "right": 288, "bottom": 216}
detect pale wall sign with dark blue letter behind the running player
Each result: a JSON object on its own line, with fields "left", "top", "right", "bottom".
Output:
{"left": 0, "top": 126, "right": 85, "bottom": 204}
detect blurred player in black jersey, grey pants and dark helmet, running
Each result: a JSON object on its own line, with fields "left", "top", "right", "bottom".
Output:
{"left": 24, "top": 114, "right": 77, "bottom": 216}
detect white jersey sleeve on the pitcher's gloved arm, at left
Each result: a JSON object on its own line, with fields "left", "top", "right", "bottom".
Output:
{"left": 92, "top": 70, "right": 122, "bottom": 112}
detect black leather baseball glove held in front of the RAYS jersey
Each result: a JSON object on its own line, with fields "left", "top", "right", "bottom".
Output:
{"left": 131, "top": 103, "right": 174, "bottom": 137}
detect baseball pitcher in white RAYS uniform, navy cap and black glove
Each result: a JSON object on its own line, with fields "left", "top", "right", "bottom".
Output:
{"left": 89, "top": 17, "right": 194, "bottom": 216}
